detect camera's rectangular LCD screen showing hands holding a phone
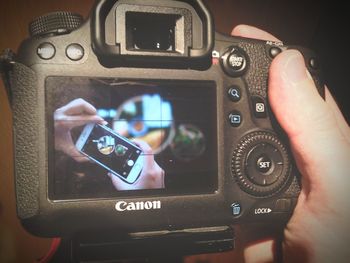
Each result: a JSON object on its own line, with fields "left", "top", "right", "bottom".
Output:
{"left": 45, "top": 77, "right": 218, "bottom": 200}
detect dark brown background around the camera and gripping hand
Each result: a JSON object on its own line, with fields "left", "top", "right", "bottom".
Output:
{"left": 0, "top": 0, "right": 350, "bottom": 263}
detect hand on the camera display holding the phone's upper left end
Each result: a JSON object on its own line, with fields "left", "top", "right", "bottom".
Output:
{"left": 54, "top": 98, "right": 106, "bottom": 162}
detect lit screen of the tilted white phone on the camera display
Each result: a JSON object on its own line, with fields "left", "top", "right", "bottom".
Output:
{"left": 80, "top": 124, "right": 141, "bottom": 179}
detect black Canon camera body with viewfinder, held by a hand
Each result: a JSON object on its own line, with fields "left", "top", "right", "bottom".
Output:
{"left": 5, "top": 0, "right": 324, "bottom": 237}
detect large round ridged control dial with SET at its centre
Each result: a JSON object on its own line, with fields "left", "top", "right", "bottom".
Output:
{"left": 231, "top": 132, "right": 291, "bottom": 197}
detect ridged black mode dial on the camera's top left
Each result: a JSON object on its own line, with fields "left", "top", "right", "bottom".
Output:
{"left": 29, "top": 12, "right": 83, "bottom": 36}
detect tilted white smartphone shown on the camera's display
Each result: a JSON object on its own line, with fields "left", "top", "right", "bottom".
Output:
{"left": 75, "top": 123, "right": 143, "bottom": 184}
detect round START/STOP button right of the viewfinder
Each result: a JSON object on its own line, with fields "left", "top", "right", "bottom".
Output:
{"left": 221, "top": 46, "right": 248, "bottom": 77}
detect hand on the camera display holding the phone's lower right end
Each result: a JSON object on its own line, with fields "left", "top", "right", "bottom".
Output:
{"left": 108, "top": 140, "right": 164, "bottom": 190}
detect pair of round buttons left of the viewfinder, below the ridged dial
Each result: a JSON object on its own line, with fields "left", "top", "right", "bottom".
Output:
{"left": 36, "top": 42, "right": 84, "bottom": 61}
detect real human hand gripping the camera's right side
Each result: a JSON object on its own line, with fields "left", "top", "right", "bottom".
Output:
{"left": 232, "top": 25, "right": 350, "bottom": 262}
